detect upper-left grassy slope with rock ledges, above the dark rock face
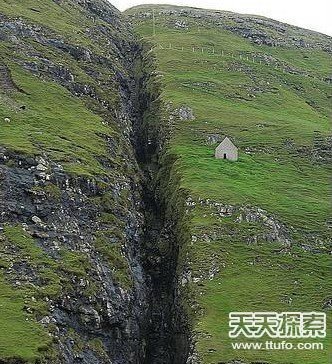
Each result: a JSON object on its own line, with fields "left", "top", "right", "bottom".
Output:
{"left": 0, "top": 0, "right": 134, "bottom": 176}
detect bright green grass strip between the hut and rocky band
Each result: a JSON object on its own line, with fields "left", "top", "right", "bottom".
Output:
{"left": 176, "top": 147, "right": 329, "bottom": 232}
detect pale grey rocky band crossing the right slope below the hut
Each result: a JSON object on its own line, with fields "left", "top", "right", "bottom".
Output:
{"left": 186, "top": 197, "right": 331, "bottom": 262}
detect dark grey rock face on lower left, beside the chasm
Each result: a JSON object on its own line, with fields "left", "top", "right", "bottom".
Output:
{"left": 0, "top": 138, "right": 148, "bottom": 363}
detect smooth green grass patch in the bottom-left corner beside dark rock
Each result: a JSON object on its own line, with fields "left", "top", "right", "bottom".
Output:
{"left": 0, "top": 226, "right": 61, "bottom": 363}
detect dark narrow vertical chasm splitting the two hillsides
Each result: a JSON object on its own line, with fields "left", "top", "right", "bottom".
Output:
{"left": 132, "top": 41, "right": 189, "bottom": 364}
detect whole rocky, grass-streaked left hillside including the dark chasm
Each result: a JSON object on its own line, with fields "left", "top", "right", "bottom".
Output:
{"left": 0, "top": 0, "right": 188, "bottom": 364}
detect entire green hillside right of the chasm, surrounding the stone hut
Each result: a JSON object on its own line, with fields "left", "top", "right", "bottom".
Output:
{"left": 127, "top": 6, "right": 332, "bottom": 364}
